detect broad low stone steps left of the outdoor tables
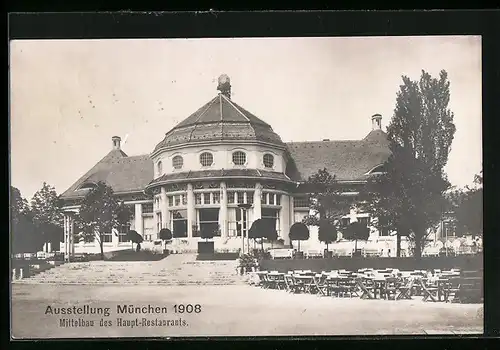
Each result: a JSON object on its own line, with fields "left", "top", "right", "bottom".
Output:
{"left": 13, "top": 254, "right": 244, "bottom": 286}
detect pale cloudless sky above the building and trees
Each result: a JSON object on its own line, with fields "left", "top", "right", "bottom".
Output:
{"left": 10, "top": 36, "right": 482, "bottom": 198}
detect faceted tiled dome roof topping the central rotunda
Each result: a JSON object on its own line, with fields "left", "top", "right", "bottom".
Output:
{"left": 154, "top": 93, "right": 285, "bottom": 152}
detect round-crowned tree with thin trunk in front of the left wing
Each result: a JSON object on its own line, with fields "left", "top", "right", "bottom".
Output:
{"left": 77, "top": 181, "right": 130, "bottom": 260}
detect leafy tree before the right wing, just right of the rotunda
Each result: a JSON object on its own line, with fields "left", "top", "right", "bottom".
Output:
{"left": 303, "top": 168, "right": 353, "bottom": 228}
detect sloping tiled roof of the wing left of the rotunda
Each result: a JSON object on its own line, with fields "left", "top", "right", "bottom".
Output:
{"left": 62, "top": 150, "right": 153, "bottom": 199}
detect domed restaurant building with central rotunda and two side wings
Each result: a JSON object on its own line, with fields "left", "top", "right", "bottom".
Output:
{"left": 61, "top": 75, "right": 400, "bottom": 252}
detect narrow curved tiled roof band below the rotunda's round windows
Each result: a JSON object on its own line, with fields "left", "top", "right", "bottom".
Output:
{"left": 148, "top": 169, "right": 290, "bottom": 187}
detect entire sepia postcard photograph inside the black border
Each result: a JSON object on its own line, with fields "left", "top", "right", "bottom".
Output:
{"left": 9, "top": 36, "right": 484, "bottom": 339}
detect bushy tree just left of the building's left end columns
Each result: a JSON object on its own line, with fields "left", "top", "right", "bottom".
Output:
{"left": 31, "top": 182, "right": 64, "bottom": 252}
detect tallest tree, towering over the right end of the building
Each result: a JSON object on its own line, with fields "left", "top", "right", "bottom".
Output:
{"left": 365, "top": 70, "right": 455, "bottom": 258}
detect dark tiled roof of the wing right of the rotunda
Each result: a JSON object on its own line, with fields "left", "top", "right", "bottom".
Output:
{"left": 286, "top": 130, "right": 390, "bottom": 181}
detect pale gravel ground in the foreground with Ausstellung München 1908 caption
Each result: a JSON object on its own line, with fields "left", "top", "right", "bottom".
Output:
{"left": 11, "top": 284, "right": 483, "bottom": 339}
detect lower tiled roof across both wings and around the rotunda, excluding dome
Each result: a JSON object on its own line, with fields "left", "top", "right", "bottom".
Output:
{"left": 62, "top": 130, "right": 390, "bottom": 199}
